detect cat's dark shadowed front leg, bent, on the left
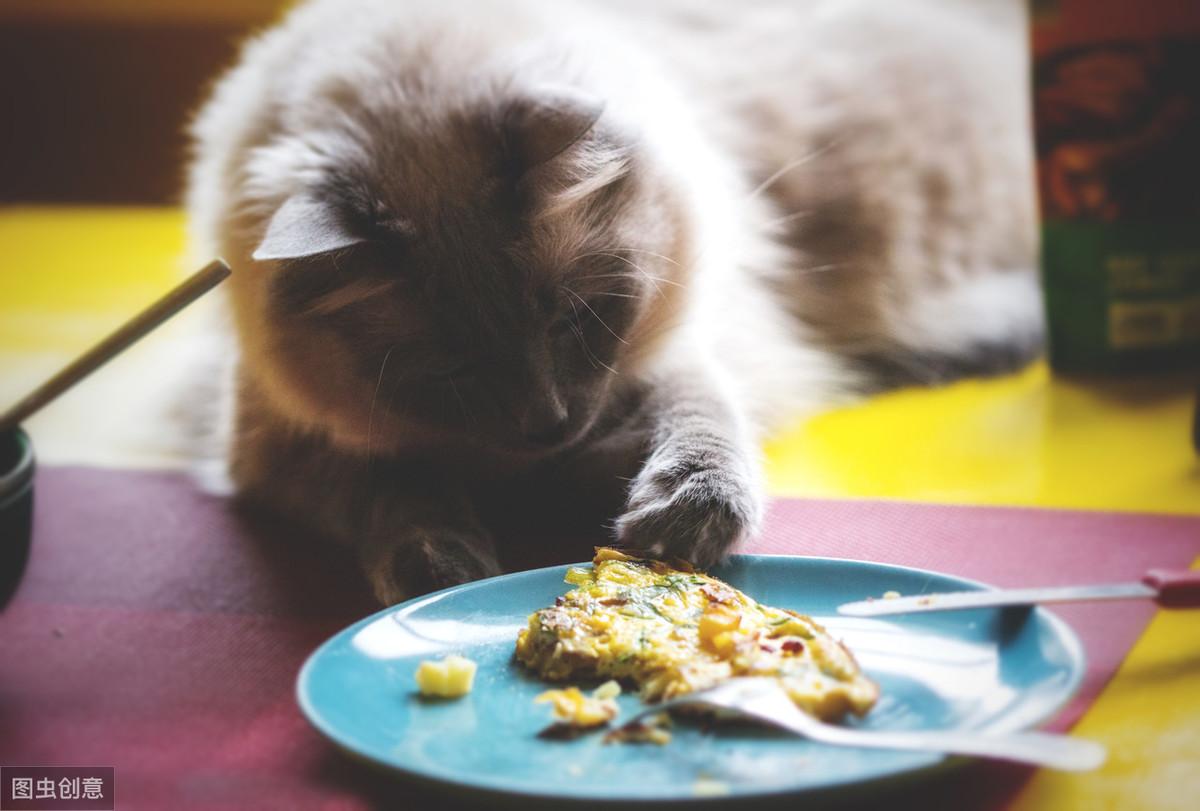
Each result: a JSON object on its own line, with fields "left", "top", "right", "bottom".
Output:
{"left": 232, "top": 412, "right": 500, "bottom": 605}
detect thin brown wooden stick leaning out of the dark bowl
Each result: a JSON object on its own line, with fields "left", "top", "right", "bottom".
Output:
{"left": 0, "top": 259, "right": 229, "bottom": 431}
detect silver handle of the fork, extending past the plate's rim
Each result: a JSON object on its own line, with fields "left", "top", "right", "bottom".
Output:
{"left": 804, "top": 727, "right": 1106, "bottom": 771}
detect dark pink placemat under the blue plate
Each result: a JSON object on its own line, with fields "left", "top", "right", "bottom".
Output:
{"left": 0, "top": 468, "right": 1200, "bottom": 809}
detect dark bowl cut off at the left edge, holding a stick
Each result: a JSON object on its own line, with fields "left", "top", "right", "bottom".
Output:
{"left": 0, "top": 428, "right": 34, "bottom": 608}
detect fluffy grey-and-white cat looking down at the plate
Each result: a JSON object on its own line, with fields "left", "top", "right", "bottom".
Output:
{"left": 187, "top": 0, "right": 1042, "bottom": 603}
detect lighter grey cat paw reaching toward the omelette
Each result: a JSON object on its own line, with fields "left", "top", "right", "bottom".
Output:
{"left": 616, "top": 453, "right": 764, "bottom": 569}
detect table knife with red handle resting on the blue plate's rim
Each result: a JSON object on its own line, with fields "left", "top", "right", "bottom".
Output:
{"left": 838, "top": 569, "right": 1200, "bottom": 617}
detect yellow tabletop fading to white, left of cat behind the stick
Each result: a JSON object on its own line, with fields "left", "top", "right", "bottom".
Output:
{"left": 0, "top": 208, "right": 198, "bottom": 465}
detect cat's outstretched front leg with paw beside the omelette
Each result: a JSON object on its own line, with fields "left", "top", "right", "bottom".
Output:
{"left": 616, "top": 360, "right": 764, "bottom": 566}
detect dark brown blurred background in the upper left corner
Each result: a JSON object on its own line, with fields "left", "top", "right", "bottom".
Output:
{"left": 0, "top": 0, "right": 287, "bottom": 204}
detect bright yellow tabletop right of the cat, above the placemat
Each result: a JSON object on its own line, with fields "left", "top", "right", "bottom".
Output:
{"left": 767, "top": 364, "right": 1200, "bottom": 513}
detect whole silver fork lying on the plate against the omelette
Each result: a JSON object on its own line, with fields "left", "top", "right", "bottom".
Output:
{"left": 618, "top": 677, "right": 1106, "bottom": 771}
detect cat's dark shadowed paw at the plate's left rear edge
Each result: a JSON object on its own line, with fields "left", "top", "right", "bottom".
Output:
{"left": 364, "top": 528, "right": 500, "bottom": 606}
